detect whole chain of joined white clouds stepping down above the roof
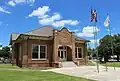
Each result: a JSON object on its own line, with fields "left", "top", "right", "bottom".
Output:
{"left": 28, "top": 6, "right": 79, "bottom": 27}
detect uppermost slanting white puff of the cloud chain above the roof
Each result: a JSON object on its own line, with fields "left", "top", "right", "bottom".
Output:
{"left": 28, "top": 6, "right": 50, "bottom": 18}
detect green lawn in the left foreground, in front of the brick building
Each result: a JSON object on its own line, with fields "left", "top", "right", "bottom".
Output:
{"left": 0, "top": 64, "right": 94, "bottom": 81}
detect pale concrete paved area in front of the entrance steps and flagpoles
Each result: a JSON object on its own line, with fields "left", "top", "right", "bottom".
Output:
{"left": 43, "top": 66, "right": 120, "bottom": 81}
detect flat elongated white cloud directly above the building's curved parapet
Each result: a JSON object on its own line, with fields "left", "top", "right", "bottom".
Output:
{"left": 52, "top": 20, "right": 79, "bottom": 27}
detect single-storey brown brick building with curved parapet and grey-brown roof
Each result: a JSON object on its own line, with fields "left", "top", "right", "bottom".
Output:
{"left": 10, "top": 26, "right": 88, "bottom": 67}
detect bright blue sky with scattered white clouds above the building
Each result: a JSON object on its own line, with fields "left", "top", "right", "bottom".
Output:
{"left": 0, "top": 0, "right": 120, "bottom": 45}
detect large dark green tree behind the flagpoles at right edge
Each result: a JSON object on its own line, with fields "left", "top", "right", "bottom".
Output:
{"left": 98, "top": 34, "right": 120, "bottom": 61}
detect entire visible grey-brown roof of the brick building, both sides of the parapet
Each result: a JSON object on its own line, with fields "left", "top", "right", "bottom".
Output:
{"left": 11, "top": 26, "right": 88, "bottom": 42}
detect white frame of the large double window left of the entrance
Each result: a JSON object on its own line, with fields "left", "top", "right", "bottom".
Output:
{"left": 31, "top": 44, "right": 47, "bottom": 60}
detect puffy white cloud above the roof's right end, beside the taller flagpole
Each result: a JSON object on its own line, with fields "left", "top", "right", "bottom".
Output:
{"left": 77, "top": 26, "right": 100, "bottom": 37}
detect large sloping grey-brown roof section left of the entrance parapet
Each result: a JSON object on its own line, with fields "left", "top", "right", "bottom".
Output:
{"left": 24, "top": 26, "right": 54, "bottom": 36}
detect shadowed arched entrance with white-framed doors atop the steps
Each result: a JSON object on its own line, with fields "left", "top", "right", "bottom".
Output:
{"left": 58, "top": 46, "right": 72, "bottom": 61}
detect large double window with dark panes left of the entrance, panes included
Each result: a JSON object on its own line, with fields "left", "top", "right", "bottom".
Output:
{"left": 32, "top": 44, "right": 46, "bottom": 59}
